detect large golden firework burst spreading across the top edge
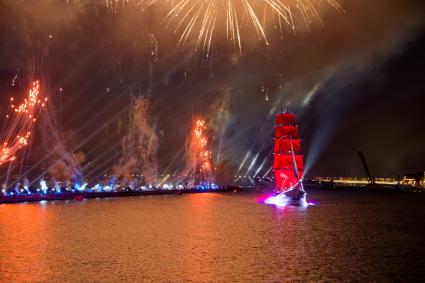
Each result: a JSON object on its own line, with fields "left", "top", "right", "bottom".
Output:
{"left": 142, "top": 0, "right": 341, "bottom": 55}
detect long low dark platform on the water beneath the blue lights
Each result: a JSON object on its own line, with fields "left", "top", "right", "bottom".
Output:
{"left": 0, "top": 187, "right": 235, "bottom": 204}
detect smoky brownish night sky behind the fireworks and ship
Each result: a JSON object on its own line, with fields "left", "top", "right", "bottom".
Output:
{"left": 0, "top": 0, "right": 425, "bottom": 179}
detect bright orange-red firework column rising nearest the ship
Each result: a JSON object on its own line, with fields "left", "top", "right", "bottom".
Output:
{"left": 182, "top": 119, "right": 213, "bottom": 187}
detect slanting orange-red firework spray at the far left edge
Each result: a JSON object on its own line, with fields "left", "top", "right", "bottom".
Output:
{"left": 0, "top": 81, "right": 47, "bottom": 168}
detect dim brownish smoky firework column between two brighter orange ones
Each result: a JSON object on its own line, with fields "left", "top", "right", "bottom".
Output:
{"left": 113, "top": 96, "right": 158, "bottom": 185}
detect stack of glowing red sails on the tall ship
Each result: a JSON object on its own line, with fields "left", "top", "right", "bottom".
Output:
{"left": 273, "top": 112, "right": 304, "bottom": 191}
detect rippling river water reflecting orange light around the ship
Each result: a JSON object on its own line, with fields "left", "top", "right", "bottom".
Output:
{"left": 0, "top": 191, "right": 425, "bottom": 282}
